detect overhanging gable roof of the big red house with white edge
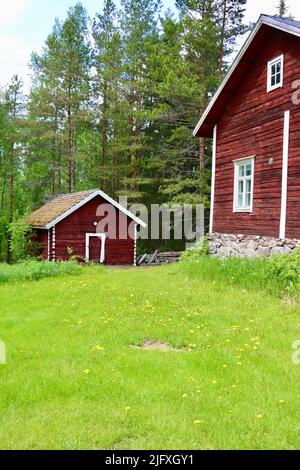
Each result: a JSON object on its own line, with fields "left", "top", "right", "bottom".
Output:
{"left": 193, "top": 15, "right": 300, "bottom": 137}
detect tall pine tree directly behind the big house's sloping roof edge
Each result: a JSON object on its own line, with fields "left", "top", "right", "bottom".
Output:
{"left": 176, "top": 0, "right": 247, "bottom": 174}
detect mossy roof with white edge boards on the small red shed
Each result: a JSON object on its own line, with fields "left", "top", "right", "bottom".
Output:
{"left": 26, "top": 189, "right": 146, "bottom": 229}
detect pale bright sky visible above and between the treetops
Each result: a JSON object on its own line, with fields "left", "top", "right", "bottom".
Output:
{"left": 0, "top": 0, "right": 300, "bottom": 92}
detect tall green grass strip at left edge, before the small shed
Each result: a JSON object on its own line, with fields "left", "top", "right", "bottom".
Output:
{"left": 0, "top": 260, "right": 83, "bottom": 283}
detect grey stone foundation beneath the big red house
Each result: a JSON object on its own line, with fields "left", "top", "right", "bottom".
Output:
{"left": 207, "top": 233, "right": 300, "bottom": 258}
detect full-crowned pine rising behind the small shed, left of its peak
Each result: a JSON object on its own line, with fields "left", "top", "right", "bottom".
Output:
{"left": 32, "top": 3, "right": 90, "bottom": 192}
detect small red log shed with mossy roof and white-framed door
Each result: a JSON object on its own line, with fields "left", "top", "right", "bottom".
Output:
{"left": 27, "top": 190, "right": 146, "bottom": 265}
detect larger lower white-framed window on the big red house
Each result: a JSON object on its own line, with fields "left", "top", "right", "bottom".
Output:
{"left": 233, "top": 157, "right": 255, "bottom": 212}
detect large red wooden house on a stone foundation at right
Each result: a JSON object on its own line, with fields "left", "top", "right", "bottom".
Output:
{"left": 194, "top": 15, "right": 300, "bottom": 256}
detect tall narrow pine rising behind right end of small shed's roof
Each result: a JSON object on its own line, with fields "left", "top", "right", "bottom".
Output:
{"left": 121, "top": 0, "right": 161, "bottom": 196}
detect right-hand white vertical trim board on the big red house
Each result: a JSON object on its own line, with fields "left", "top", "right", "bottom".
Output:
{"left": 279, "top": 111, "right": 290, "bottom": 240}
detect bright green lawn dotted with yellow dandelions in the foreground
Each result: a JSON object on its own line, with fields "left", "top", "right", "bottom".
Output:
{"left": 0, "top": 265, "right": 300, "bottom": 450}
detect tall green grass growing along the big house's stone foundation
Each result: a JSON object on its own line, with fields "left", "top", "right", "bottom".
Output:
{"left": 180, "top": 250, "right": 300, "bottom": 295}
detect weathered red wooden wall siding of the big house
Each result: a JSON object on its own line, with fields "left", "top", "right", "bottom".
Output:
{"left": 213, "top": 30, "right": 300, "bottom": 238}
